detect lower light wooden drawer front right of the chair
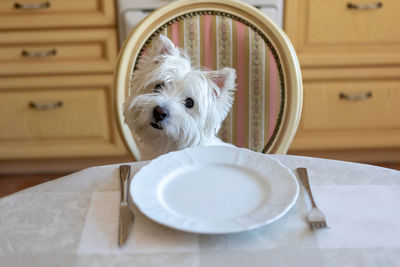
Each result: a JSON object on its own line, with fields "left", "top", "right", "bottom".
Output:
{"left": 291, "top": 80, "right": 400, "bottom": 151}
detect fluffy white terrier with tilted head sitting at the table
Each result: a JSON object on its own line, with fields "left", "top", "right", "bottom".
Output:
{"left": 124, "top": 35, "right": 236, "bottom": 160}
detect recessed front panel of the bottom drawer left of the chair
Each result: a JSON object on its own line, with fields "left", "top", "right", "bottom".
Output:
{"left": 0, "top": 88, "right": 108, "bottom": 141}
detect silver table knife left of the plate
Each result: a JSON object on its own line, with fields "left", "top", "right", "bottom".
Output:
{"left": 118, "top": 165, "right": 133, "bottom": 246}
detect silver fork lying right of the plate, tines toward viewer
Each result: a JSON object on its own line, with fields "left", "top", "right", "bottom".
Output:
{"left": 297, "top": 168, "right": 328, "bottom": 229}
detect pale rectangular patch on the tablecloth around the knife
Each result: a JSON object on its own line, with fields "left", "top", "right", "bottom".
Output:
{"left": 78, "top": 191, "right": 199, "bottom": 254}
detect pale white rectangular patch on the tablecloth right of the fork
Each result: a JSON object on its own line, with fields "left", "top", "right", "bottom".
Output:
{"left": 312, "top": 185, "right": 400, "bottom": 249}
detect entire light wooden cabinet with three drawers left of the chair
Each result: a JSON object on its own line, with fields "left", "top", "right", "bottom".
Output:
{"left": 0, "top": 0, "right": 127, "bottom": 172}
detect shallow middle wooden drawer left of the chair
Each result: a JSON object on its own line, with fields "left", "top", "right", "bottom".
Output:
{"left": 0, "top": 29, "right": 117, "bottom": 75}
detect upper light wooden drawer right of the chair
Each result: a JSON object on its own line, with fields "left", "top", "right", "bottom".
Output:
{"left": 285, "top": 0, "right": 400, "bottom": 69}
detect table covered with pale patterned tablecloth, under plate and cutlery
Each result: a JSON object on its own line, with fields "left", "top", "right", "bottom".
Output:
{"left": 0, "top": 149, "right": 400, "bottom": 267}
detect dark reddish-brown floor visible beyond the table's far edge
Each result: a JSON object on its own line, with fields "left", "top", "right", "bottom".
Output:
{"left": 0, "top": 163, "right": 400, "bottom": 197}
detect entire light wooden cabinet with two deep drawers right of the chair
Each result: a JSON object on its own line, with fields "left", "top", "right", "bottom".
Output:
{"left": 284, "top": 0, "right": 400, "bottom": 162}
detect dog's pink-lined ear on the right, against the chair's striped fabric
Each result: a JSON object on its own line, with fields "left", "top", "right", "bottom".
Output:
{"left": 207, "top": 68, "right": 236, "bottom": 98}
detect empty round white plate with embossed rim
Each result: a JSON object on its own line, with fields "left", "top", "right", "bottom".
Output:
{"left": 130, "top": 146, "right": 299, "bottom": 234}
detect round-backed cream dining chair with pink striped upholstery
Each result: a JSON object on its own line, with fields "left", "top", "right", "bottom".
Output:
{"left": 114, "top": 0, "right": 303, "bottom": 160}
